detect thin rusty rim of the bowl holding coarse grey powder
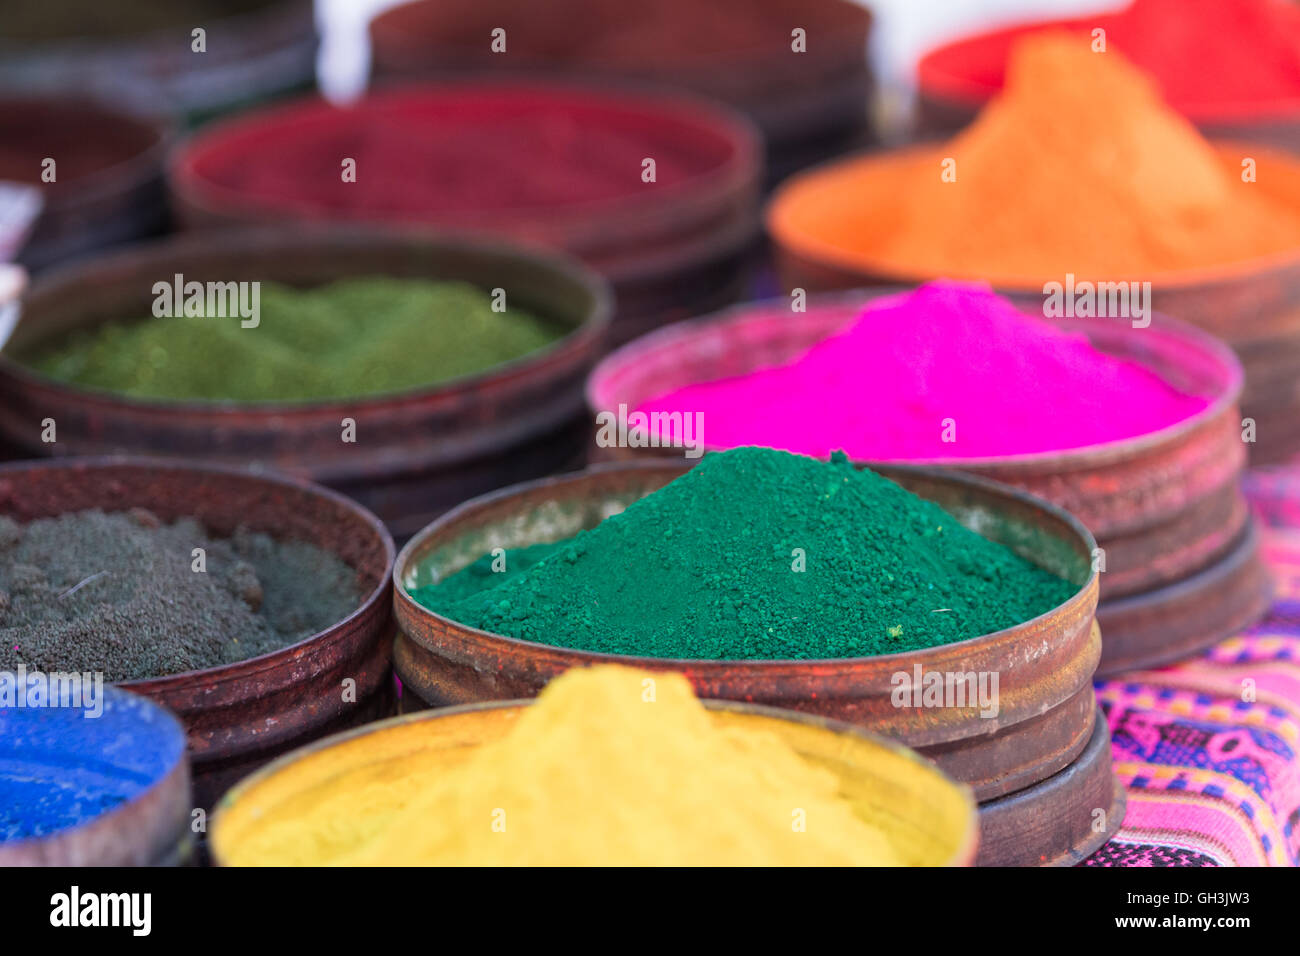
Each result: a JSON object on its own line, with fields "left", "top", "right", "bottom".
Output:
{"left": 0, "top": 455, "right": 395, "bottom": 686}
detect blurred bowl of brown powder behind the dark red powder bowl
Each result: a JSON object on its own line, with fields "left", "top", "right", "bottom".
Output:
{"left": 369, "top": 0, "right": 874, "bottom": 183}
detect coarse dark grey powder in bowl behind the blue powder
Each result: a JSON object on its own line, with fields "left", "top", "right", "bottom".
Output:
{"left": 0, "top": 509, "right": 360, "bottom": 682}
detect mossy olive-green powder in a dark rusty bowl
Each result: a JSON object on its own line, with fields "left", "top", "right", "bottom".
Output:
{"left": 16, "top": 277, "right": 568, "bottom": 402}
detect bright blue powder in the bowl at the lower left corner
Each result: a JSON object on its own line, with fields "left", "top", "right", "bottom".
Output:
{"left": 0, "top": 687, "right": 185, "bottom": 843}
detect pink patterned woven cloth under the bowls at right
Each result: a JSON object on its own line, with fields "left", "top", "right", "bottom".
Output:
{"left": 1080, "top": 467, "right": 1300, "bottom": 866}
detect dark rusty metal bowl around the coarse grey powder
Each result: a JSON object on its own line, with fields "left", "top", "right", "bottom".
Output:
{"left": 0, "top": 458, "right": 394, "bottom": 806}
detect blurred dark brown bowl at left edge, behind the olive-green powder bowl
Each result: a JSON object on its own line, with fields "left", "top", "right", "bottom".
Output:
{"left": 0, "top": 96, "right": 172, "bottom": 269}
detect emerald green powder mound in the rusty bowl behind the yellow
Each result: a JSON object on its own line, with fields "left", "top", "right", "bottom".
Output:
{"left": 413, "top": 447, "right": 1078, "bottom": 659}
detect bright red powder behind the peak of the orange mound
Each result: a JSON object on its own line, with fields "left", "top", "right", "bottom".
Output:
{"left": 919, "top": 0, "right": 1300, "bottom": 121}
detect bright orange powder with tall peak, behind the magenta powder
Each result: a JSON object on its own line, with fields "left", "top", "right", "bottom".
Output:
{"left": 768, "top": 34, "right": 1300, "bottom": 287}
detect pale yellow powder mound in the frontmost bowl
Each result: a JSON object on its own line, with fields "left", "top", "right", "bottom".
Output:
{"left": 218, "top": 666, "right": 900, "bottom": 865}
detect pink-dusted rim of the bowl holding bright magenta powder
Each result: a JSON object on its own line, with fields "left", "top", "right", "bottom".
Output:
{"left": 584, "top": 284, "right": 1245, "bottom": 473}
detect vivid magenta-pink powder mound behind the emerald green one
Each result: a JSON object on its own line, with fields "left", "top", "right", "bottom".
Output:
{"left": 640, "top": 282, "right": 1209, "bottom": 460}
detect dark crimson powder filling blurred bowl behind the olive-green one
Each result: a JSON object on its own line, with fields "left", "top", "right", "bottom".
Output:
{"left": 172, "top": 83, "right": 758, "bottom": 240}
